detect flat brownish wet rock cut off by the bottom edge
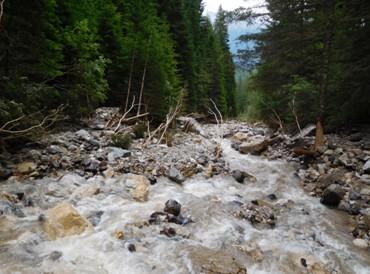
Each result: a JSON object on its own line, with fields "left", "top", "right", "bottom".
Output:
{"left": 188, "top": 247, "right": 247, "bottom": 274}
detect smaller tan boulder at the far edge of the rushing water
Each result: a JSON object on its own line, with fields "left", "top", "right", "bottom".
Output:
{"left": 126, "top": 174, "right": 150, "bottom": 202}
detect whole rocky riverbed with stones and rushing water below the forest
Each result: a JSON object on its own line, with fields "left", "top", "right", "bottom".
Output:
{"left": 0, "top": 109, "right": 370, "bottom": 274}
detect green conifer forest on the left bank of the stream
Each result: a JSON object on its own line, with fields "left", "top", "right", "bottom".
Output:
{"left": 0, "top": 0, "right": 236, "bottom": 133}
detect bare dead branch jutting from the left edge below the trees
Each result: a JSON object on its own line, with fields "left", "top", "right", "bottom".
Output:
{"left": 0, "top": 105, "right": 64, "bottom": 136}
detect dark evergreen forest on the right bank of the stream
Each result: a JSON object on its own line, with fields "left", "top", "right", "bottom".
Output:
{"left": 237, "top": 0, "right": 370, "bottom": 128}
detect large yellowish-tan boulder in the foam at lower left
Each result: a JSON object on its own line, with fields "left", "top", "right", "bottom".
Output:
{"left": 43, "top": 202, "right": 92, "bottom": 240}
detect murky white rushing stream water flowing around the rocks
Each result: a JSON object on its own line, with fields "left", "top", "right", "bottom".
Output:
{"left": 0, "top": 136, "right": 370, "bottom": 274}
